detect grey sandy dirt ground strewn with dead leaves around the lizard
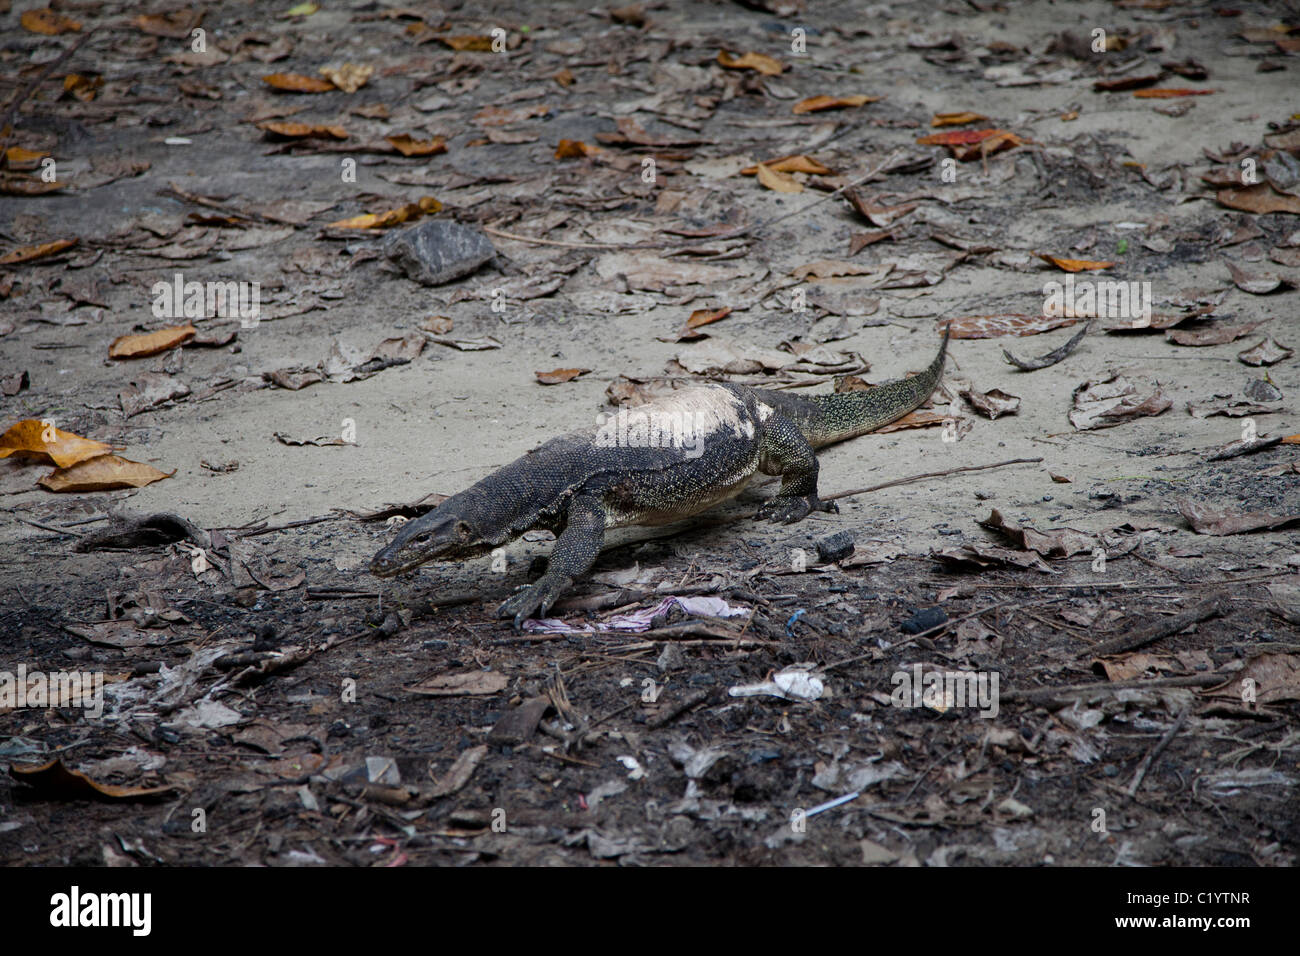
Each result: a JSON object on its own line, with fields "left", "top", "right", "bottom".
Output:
{"left": 0, "top": 0, "right": 1300, "bottom": 866}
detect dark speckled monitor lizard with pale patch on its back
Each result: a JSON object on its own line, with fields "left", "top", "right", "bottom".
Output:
{"left": 371, "top": 332, "right": 948, "bottom": 628}
